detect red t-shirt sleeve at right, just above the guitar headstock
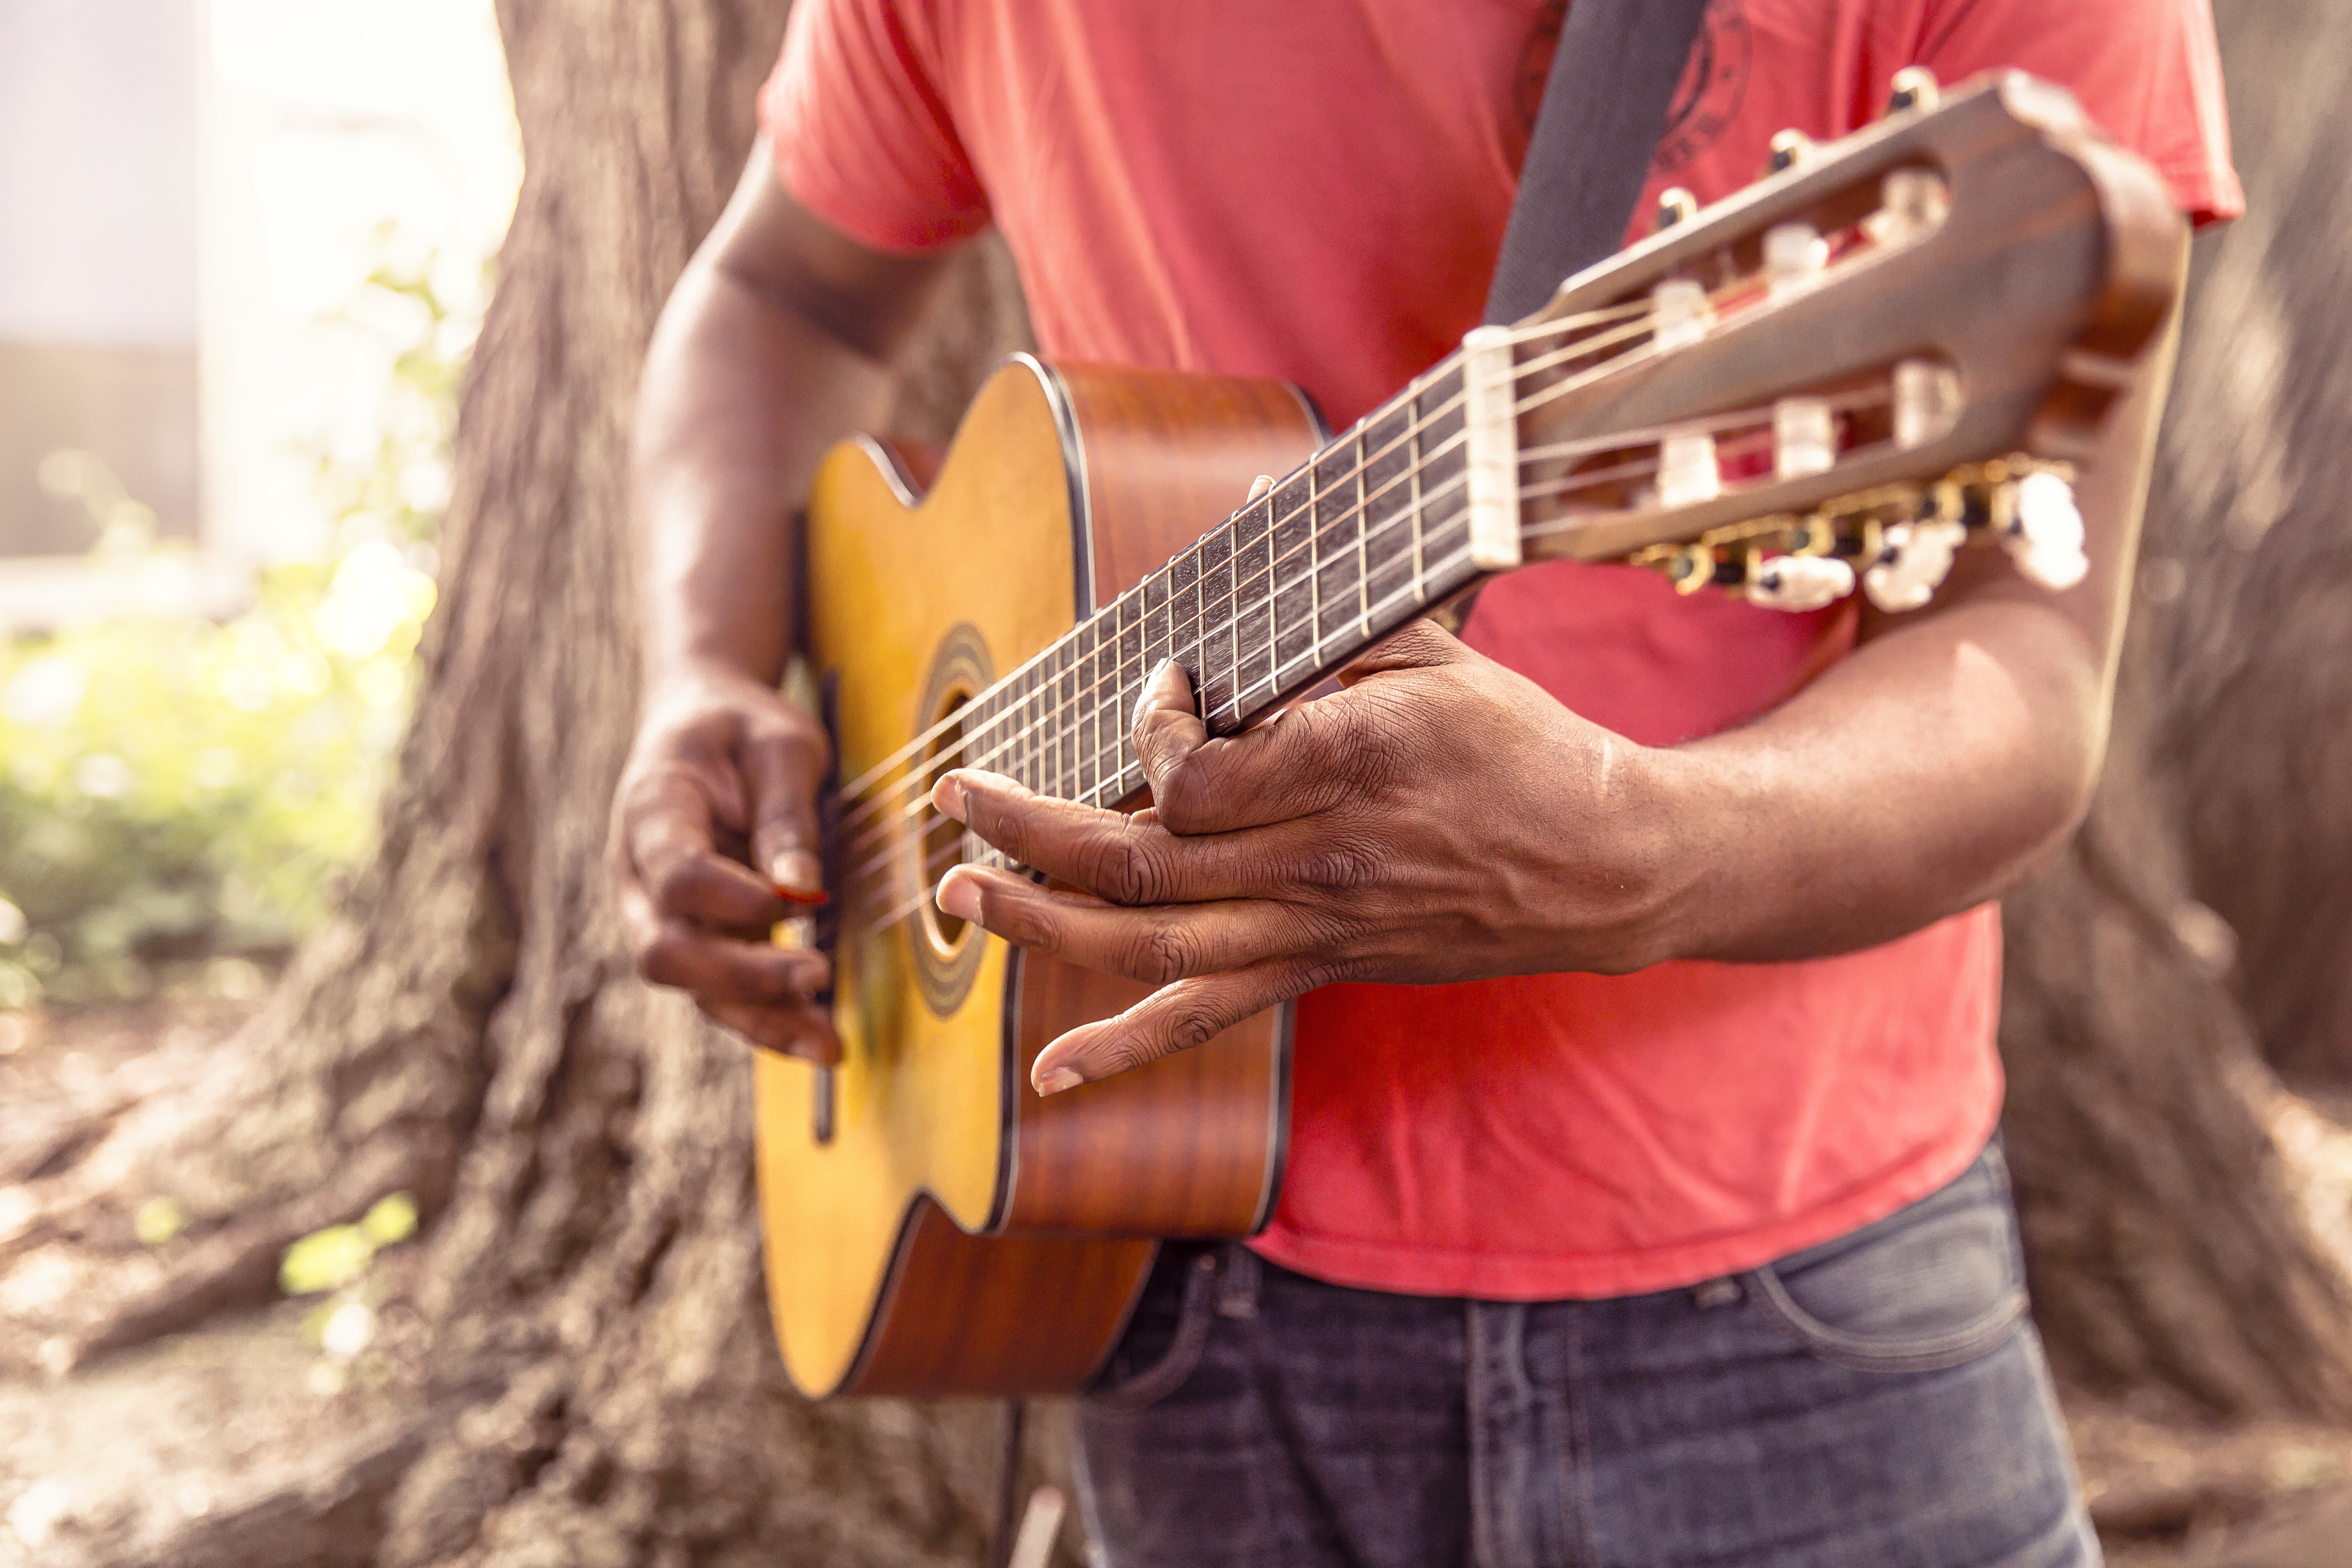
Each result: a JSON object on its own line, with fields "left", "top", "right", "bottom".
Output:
{"left": 1919, "top": 0, "right": 2246, "bottom": 223}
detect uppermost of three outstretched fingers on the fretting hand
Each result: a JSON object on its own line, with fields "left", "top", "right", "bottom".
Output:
{"left": 931, "top": 769, "right": 1301, "bottom": 905}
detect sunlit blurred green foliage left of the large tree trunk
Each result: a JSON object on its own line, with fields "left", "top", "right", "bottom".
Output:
{"left": 0, "top": 245, "right": 470, "bottom": 1009}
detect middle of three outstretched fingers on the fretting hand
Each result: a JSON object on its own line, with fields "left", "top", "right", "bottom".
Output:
{"left": 939, "top": 865, "right": 1317, "bottom": 985}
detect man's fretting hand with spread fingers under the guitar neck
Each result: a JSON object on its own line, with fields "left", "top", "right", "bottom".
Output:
{"left": 931, "top": 623, "right": 1670, "bottom": 1093}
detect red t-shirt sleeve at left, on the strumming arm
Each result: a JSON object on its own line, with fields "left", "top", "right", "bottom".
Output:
{"left": 760, "top": 0, "right": 988, "bottom": 252}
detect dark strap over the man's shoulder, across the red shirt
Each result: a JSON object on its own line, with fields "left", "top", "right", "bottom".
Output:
{"left": 1486, "top": 0, "right": 1707, "bottom": 324}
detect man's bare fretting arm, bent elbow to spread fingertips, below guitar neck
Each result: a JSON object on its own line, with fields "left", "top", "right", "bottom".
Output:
{"left": 934, "top": 306, "right": 2171, "bottom": 1091}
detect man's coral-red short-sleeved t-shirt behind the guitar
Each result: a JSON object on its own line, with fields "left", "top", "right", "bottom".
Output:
{"left": 760, "top": 0, "right": 2242, "bottom": 1300}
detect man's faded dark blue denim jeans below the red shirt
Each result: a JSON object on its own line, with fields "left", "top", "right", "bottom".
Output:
{"left": 1080, "top": 1145, "right": 2098, "bottom": 1568}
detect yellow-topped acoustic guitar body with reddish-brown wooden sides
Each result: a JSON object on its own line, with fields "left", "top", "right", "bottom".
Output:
{"left": 758, "top": 355, "right": 1319, "bottom": 1396}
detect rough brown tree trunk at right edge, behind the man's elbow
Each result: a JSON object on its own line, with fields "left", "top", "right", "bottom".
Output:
{"left": 2002, "top": 0, "right": 2352, "bottom": 1418}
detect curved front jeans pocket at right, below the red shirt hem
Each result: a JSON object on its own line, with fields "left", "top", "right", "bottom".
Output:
{"left": 1750, "top": 1147, "right": 2025, "bottom": 1373}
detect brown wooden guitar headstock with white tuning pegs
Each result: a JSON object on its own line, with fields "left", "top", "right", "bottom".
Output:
{"left": 1465, "top": 73, "right": 2185, "bottom": 609}
